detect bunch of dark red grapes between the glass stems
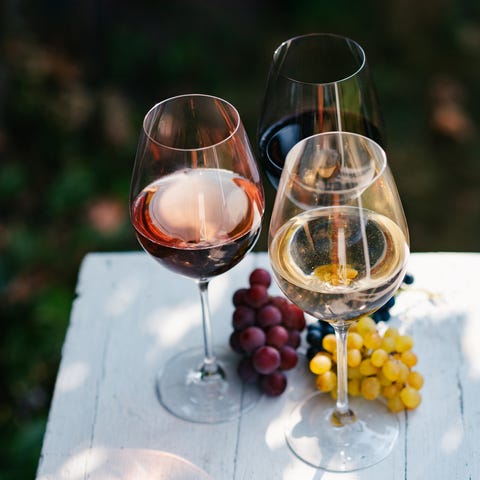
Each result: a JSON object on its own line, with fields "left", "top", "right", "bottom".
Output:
{"left": 230, "top": 268, "right": 306, "bottom": 396}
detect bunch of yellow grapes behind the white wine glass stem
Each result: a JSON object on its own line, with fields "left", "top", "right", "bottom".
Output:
{"left": 309, "top": 317, "right": 423, "bottom": 412}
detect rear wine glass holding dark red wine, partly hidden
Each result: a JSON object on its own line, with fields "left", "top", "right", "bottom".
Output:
{"left": 257, "top": 33, "right": 385, "bottom": 188}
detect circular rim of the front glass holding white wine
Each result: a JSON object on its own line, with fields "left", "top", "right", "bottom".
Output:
{"left": 282, "top": 131, "right": 387, "bottom": 195}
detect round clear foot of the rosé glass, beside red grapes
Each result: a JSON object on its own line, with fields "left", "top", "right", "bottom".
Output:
{"left": 156, "top": 348, "right": 261, "bottom": 423}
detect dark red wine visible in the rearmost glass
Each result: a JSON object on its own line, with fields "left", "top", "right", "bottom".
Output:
{"left": 259, "top": 109, "right": 384, "bottom": 188}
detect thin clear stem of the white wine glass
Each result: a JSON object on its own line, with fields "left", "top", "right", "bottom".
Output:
{"left": 332, "top": 323, "right": 355, "bottom": 426}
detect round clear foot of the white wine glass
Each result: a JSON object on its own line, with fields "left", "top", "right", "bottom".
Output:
{"left": 285, "top": 392, "right": 399, "bottom": 472}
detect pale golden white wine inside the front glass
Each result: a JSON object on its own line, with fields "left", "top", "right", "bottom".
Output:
{"left": 269, "top": 206, "right": 409, "bottom": 322}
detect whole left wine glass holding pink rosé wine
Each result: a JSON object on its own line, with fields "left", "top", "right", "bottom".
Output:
{"left": 130, "top": 94, "right": 264, "bottom": 423}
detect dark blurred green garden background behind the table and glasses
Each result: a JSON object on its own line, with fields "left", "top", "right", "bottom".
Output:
{"left": 0, "top": 0, "right": 480, "bottom": 480}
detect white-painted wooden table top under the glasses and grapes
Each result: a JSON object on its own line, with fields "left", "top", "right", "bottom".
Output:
{"left": 37, "top": 253, "right": 480, "bottom": 480}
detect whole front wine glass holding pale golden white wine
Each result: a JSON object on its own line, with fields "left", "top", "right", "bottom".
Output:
{"left": 269, "top": 132, "right": 409, "bottom": 471}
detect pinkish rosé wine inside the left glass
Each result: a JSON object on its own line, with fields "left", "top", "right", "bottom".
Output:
{"left": 131, "top": 168, "right": 264, "bottom": 279}
